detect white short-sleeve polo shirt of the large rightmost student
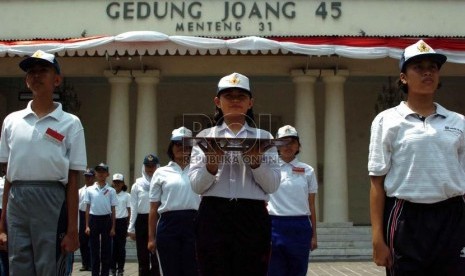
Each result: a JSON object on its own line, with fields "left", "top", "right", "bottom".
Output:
{"left": 368, "top": 102, "right": 465, "bottom": 203}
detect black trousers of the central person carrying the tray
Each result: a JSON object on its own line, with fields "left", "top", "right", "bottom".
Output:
{"left": 196, "top": 197, "right": 271, "bottom": 276}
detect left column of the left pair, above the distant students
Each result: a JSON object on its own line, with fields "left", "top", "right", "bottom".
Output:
{"left": 104, "top": 70, "right": 132, "bottom": 180}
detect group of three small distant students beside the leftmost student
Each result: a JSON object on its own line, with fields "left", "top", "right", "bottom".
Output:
{"left": 79, "top": 163, "right": 130, "bottom": 275}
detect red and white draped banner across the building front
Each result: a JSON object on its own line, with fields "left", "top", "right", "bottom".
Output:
{"left": 0, "top": 31, "right": 465, "bottom": 63}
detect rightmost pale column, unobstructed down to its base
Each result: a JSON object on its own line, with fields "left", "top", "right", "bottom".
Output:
{"left": 322, "top": 70, "right": 349, "bottom": 222}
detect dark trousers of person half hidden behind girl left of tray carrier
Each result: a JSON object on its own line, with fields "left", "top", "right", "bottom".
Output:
{"left": 134, "top": 214, "right": 160, "bottom": 276}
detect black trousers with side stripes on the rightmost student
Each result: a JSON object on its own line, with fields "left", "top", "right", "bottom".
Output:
{"left": 384, "top": 196, "right": 465, "bottom": 276}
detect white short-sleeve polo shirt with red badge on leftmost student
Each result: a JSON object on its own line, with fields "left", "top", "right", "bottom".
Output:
{"left": 0, "top": 101, "right": 87, "bottom": 184}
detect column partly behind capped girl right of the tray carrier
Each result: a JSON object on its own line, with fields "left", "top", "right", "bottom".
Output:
{"left": 291, "top": 70, "right": 321, "bottom": 220}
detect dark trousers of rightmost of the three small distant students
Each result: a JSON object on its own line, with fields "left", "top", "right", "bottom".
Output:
{"left": 111, "top": 217, "right": 128, "bottom": 272}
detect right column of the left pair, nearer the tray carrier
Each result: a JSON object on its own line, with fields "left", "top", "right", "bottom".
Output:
{"left": 133, "top": 70, "right": 160, "bottom": 179}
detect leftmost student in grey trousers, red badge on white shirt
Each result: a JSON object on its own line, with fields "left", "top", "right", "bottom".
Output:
{"left": 0, "top": 50, "right": 87, "bottom": 275}
